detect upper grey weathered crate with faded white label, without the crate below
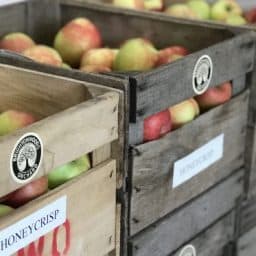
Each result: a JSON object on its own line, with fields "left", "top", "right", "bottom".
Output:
{"left": 0, "top": 0, "right": 255, "bottom": 254}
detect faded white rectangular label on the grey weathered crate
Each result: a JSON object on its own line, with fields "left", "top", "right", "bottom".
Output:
{"left": 172, "top": 134, "right": 224, "bottom": 188}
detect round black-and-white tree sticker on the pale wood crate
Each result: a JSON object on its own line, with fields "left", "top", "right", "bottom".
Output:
{"left": 10, "top": 133, "right": 43, "bottom": 183}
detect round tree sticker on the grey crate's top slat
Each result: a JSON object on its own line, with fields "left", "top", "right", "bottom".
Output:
{"left": 192, "top": 55, "right": 213, "bottom": 95}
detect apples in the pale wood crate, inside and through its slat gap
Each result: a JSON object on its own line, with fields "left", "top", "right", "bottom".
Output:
{"left": 0, "top": 110, "right": 90, "bottom": 217}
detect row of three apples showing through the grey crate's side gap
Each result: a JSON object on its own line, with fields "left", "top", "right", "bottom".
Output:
{"left": 143, "top": 82, "right": 232, "bottom": 142}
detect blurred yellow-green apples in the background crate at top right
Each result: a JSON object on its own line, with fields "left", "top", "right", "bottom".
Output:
{"left": 112, "top": 0, "right": 256, "bottom": 25}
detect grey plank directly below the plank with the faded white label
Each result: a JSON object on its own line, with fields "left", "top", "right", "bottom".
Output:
{"left": 130, "top": 170, "right": 244, "bottom": 256}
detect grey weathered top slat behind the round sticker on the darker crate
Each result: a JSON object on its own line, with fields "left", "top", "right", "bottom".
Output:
{"left": 135, "top": 34, "right": 255, "bottom": 119}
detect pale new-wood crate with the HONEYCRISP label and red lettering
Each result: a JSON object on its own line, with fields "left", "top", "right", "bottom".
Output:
{"left": 0, "top": 64, "right": 122, "bottom": 256}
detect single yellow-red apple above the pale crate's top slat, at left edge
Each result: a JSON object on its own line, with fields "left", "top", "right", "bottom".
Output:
{"left": 0, "top": 110, "right": 36, "bottom": 136}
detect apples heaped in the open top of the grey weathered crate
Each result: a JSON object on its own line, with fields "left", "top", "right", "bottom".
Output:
{"left": 0, "top": 18, "right": 192, "bottom": 72}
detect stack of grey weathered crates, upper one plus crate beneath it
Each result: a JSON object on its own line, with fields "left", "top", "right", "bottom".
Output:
{"left": 0, "top": 0, "right": 255, "bottom": 256}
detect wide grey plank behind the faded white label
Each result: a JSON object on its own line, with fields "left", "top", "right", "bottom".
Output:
{"left": 130, "top": 91, "right": 249, "bottom": 235}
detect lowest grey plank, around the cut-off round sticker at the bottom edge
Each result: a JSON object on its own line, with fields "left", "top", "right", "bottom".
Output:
{"left": 170, "top": 212, "right": 235, "bottom": 256}
